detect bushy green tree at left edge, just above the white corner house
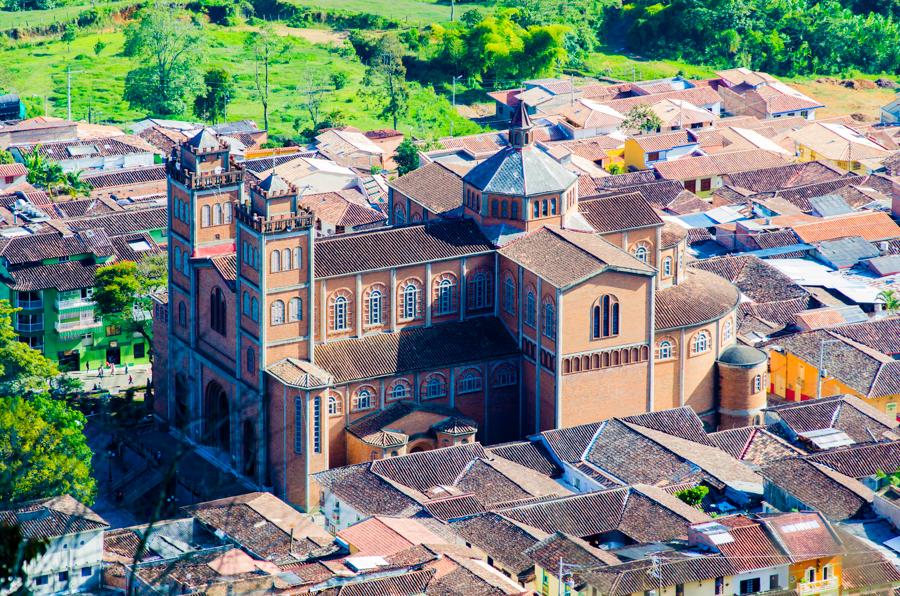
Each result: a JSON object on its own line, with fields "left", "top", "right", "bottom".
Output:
{"left": 0, "top": 394, "right": 96, "bottom": 504}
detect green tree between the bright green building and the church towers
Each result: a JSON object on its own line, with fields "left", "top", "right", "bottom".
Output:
{"left": 93, "top": 253, "right": 168, "bottom": 350}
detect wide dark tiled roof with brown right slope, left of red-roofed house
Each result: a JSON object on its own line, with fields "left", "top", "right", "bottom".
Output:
{"left": 499, "top": 485, "right": 710, "bottom": 542}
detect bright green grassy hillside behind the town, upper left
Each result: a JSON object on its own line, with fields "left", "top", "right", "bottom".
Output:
{"left": 0, "top": 26, "right": 477, "bottom": 136}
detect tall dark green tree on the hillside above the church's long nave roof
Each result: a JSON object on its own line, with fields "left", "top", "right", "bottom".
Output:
{"left": 363, "top": 33, "right": 409, "bottom": 129}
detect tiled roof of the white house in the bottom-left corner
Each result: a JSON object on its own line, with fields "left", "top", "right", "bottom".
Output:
{"left": 0, "top": 495, "right": 109, "bottom": 539}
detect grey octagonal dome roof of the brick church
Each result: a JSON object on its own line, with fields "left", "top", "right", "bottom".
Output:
{"left": 463, "top": 145, "right": 578, "bottom": 197}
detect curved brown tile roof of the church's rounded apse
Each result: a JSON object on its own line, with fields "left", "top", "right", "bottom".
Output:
{"left": 655, "top": 268, "right": 740, "bottom": 331}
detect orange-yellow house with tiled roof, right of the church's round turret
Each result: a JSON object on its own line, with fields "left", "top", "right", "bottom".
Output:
{"left": 769, "top": 328, "right": 900, "bottom": 416}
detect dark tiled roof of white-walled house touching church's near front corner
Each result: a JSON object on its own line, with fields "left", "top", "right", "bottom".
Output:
{"left": 315, "top": 463, "right": 422, "bottom": 517}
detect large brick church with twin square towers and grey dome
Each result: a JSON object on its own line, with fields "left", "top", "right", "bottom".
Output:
{"left": 154, "top": 110, "right": 766, "bottom": 508}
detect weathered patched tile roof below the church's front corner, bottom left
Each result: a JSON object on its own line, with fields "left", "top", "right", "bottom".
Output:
{"left": 184, "top": 492, "right": 337, "bottom": 565}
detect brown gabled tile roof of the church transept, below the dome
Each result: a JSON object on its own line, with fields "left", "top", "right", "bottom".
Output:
{"left": 499, "top": 226, "right": 653, "bottom": 288}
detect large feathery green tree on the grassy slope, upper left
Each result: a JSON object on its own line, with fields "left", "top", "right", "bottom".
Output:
{"left": 123, "top": 3, "right": 203, "bottom": 115}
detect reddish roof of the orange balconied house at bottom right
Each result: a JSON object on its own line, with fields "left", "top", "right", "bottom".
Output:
{"left": 757, "top": 512, "right": 844, "bottom": 563}
